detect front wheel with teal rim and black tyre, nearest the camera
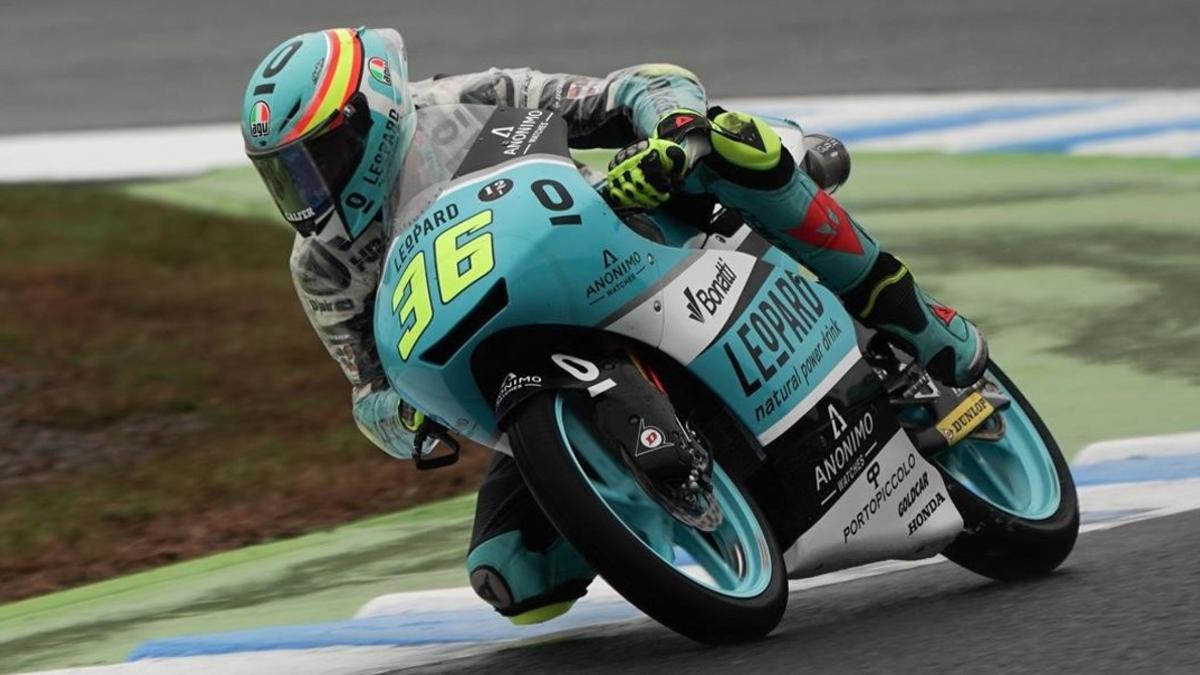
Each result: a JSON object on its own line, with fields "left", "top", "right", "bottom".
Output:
{"left": 509, "top": 390, "right": 787, "bottom": 644}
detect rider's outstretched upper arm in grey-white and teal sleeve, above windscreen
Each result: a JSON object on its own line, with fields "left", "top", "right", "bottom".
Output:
{"left": 413, "top": 64, "right": 707, "bottom": 148}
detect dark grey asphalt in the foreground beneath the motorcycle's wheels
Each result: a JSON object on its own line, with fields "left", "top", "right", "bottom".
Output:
{"left": 392, "top": 512, "right": 1200, "bottom": 674}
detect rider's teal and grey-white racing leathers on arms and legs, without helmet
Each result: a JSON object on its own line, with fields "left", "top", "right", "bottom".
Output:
{"left": 292, "top": 64, "right": 986, "bottom": 623}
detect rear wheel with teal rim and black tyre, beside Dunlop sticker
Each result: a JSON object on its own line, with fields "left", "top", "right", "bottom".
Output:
{"left": 931, "top": 363, "right": 1079, "bottom": 580}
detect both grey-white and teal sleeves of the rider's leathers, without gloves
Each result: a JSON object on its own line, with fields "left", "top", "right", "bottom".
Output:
{"left": 290, "top": 64, "right": 706, "bottom": 458}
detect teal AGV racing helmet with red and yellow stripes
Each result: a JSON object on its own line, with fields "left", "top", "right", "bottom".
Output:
{"left": 241, "top": 28, "right": 415, "bottom": 240}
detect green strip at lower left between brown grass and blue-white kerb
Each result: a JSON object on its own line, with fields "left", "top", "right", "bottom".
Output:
{"left": 0, "top": 495, "right": 474, "bottom": 673}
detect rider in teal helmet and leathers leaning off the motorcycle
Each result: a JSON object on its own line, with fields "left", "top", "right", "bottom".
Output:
{"left": 242, "top": 29, "right": 986, "bottom": 623}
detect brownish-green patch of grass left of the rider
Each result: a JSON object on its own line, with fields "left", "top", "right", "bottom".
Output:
{"left": 0, "top": 186, "right": 486, "bottom": 599}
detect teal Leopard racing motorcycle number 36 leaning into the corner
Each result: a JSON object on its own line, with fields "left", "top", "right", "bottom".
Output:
{"left": 374, "top": 106, "right": 1079, "bottom": 643}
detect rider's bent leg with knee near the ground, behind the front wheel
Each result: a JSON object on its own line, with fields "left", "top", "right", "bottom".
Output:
{"left": 467, "top": 453, "right": 595, "bottom": 625}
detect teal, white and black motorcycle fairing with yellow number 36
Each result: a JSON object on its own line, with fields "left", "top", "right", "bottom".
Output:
{"left": 374, "top": 105, "right": 961, "bottom": 574}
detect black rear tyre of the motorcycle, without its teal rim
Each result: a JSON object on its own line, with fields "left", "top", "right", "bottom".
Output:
{"left": 942, "top": 363, "right": 1079, "bottom": 581}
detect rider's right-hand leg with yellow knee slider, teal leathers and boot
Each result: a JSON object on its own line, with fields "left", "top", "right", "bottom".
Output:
{"left": 685, "top": 112, "right": 988, "bottom": 386}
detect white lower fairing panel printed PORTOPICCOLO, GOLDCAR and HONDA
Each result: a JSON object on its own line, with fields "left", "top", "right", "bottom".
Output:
{"left": 784, "top": 431, "right": 962, "bottom": 579}
